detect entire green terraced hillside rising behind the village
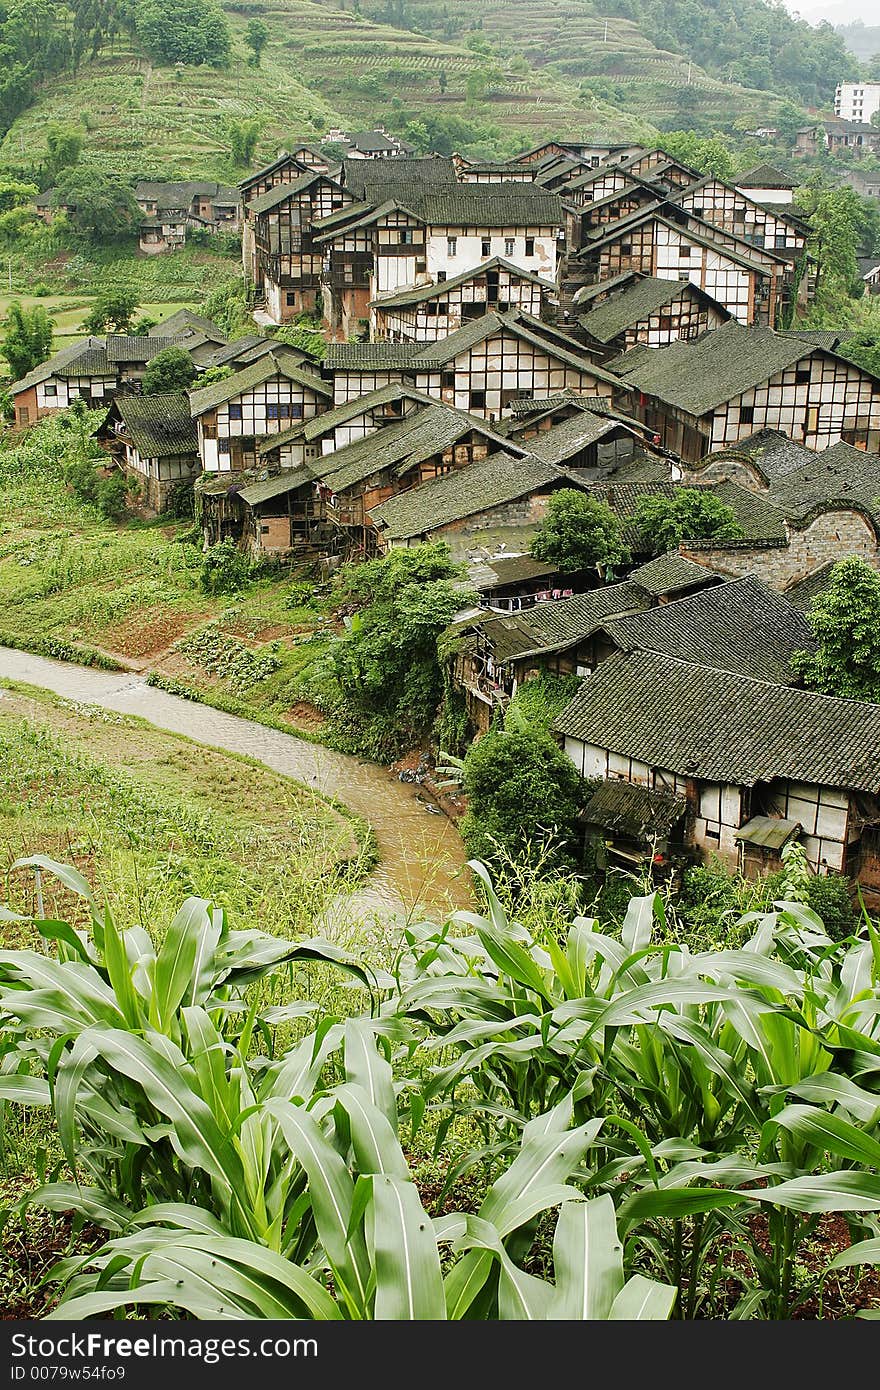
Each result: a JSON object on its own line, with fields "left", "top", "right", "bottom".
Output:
{"left": 0, "top": 0, "right": 795, "bottom": 178}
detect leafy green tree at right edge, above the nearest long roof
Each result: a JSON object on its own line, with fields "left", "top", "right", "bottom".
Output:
{"left": 791, "top": 555, "right": 880, "bottom": 703}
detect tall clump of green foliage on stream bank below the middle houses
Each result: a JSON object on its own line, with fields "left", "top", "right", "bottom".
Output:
{"left": 332, "top": 542, "right": 470, "bottom": 756}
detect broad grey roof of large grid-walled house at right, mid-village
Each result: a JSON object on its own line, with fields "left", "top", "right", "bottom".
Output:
{"left": 608, "top": 318, "right": 819, "bottom": 416}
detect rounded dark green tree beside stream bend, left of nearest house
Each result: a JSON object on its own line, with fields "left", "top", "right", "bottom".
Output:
{"left": 462, "top": 728, "right": 585, "bottom": 863}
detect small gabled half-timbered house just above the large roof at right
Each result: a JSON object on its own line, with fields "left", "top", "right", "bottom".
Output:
{"left": 574, "top": 271, "right": 731, "bottom": 361}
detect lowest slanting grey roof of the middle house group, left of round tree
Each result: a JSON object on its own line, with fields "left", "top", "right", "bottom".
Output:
{"left": 373, "top": 452, "right": 570, "bottom": 541}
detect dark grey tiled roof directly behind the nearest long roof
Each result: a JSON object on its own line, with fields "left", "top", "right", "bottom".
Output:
{"left": 609, "top": 575, "right": 816, "bottom": 685}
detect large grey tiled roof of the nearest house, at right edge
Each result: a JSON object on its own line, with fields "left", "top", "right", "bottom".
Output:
{"left": 555, "top": 652, "right": 880, "bottom": 794}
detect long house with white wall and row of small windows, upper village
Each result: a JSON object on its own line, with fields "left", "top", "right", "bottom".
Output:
{"left": 318, "top": 184, "right": 564, "bottom": 336}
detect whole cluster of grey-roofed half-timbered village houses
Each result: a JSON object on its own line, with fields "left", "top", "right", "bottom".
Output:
{"left": 11, "top": 132, "right": 880, "bottom": 901}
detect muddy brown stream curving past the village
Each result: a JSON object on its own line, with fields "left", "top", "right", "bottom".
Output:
{"left": 0, "top": 646, "right": 471, "bottom": 920}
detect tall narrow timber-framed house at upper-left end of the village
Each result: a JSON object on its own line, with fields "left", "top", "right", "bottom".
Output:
{"left": 246, "top": 172, "right": 352, "bottom": 324}
